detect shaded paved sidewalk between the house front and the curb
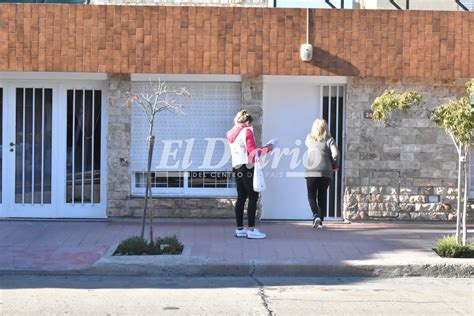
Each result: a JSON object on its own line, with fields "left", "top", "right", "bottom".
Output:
{"left": 0, "top": 219, "right": 472, "bottom": 271}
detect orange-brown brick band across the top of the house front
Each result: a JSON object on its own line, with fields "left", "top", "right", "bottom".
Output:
{"left": 0, "top": 4, "right": 474, "bottom": 78}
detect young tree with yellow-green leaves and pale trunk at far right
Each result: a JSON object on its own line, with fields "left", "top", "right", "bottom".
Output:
{"left": 372, "top": 80, "right": 474, "bottom": 245}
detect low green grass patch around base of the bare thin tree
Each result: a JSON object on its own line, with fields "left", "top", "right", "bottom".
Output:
{"left": 114, "top": 235, "right": 184, "bottom": 256}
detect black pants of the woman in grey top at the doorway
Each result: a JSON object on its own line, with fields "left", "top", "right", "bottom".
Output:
{"left": 306, "top": 177, "right": 331, "bottom": 221}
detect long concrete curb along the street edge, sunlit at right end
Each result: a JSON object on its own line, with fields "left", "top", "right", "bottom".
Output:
{"left": 0, "top": 262, "right": 474, "bottom": 278}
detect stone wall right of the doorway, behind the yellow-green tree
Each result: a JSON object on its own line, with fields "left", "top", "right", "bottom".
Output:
{"left": 344, "top": 78, "right": 474, "bottom": 220}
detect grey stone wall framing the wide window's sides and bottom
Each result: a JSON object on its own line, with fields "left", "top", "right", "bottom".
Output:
{"left": 107, "top": 74, "right": 263, "bottom": 218}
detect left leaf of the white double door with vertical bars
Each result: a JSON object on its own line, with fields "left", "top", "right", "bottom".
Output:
{"left": 4, "top": 84, "right": 57, "bottom": 217}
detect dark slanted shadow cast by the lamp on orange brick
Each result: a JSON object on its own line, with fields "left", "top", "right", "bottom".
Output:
{"left": 310, "top": 46, "right": 360, "bottom": 77}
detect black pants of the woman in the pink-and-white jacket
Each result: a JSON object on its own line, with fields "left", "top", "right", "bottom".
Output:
{"left": 233, "top": 165, "right": 258, "bottom": 227}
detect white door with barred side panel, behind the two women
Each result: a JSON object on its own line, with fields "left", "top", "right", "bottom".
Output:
{"left": 261, "top": 78, "right": 344, "bottom": 220}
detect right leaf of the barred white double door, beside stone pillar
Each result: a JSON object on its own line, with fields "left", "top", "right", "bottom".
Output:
{"left": 58, "top": 83, "right": 107, "bottom": 218}
